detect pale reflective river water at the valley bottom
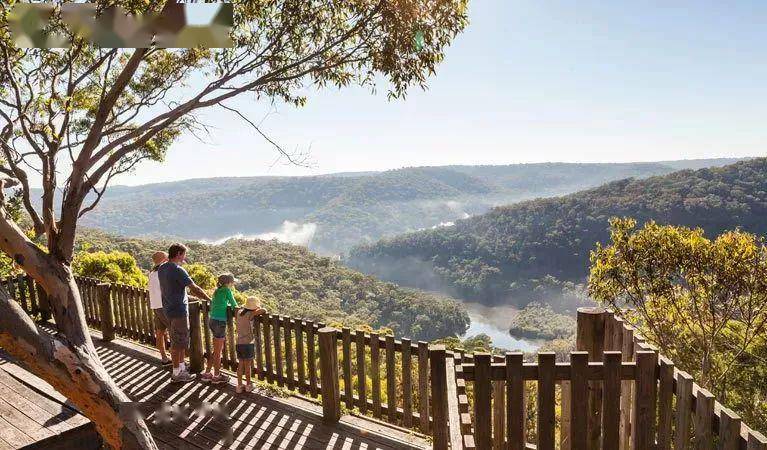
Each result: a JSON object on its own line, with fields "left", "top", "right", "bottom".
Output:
{"left": 462, "top": 302, "right": 541, "bottom": 353}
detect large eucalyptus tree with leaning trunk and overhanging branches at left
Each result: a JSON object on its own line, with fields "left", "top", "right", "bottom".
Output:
{"left": 0, "top": 0, "right": 467, "bottom": 448}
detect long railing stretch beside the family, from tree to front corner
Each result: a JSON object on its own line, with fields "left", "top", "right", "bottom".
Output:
{"left": 72, "top": 278, "right": 440, "bottom": 434}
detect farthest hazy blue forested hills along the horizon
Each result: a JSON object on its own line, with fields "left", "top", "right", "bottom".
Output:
{"left": 69, "top": 159, "right": 732, "bottom": 254}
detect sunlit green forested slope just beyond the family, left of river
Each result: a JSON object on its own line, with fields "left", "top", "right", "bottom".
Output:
{"left": 78, "top": 230, "right": 469, "bottom": 340}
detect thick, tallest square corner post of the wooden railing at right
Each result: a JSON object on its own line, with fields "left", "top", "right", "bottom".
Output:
{"left": 570, "top": 307, "right": 607, "bottom": 449}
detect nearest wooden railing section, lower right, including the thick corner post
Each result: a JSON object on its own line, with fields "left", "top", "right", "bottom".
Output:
{"left": 449, "top": 308, "right": 767, "bottom": 450}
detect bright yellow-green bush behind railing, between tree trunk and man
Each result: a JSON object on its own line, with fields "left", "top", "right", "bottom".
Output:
{"left": 72, "top": 251, "right": 148, "bottom": 287}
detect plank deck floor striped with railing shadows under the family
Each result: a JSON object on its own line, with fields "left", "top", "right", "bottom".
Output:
{"left": 0, "top": 326, "right": 431, "bottom": 450}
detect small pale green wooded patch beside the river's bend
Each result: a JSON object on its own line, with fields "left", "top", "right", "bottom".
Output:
{"left": 509, "top": 302, "right": 575, "bottom": 340}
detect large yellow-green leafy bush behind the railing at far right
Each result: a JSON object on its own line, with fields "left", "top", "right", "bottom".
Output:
{"left": 589, "top": 219, "right": 767, "bottom": 428}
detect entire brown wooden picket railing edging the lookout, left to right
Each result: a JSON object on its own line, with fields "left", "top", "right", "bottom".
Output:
{"left": 1, "top": 277, "right": 767, "bottom": 450}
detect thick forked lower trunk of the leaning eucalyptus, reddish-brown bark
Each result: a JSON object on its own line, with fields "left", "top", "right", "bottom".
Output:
{"left": 0, "top": 211, "right": 157, "bottom": 449}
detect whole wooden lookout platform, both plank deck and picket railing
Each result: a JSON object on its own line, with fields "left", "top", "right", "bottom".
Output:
{"left": 0, "top": 277, "right": 767, "bottom": 450}
